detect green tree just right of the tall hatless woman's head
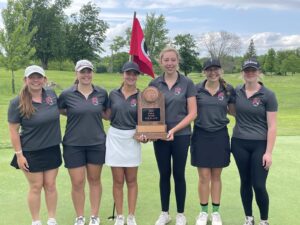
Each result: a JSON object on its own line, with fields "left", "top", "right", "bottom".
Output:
{"left": 174, "top": 34, "right": 199, "bottom": 76}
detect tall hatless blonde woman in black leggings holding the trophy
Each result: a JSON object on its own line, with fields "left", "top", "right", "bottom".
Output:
{"left": 149, "top": 47, "right": 197, "bottom": 225}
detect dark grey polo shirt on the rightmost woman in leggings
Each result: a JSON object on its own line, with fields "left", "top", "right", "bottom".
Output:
{"left": 232, "top": 83, "right": 278, "bottom": 140}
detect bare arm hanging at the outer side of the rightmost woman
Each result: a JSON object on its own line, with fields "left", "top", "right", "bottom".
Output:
{"left": 262, "top": 112, "right": 277, "bottom": 169}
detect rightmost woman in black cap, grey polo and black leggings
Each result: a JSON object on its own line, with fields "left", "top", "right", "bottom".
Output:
{"left": 231, "top": 59, "right": 278, "bottom": 225}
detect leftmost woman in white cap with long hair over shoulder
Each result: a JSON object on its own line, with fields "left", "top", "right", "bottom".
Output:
{"left": 8, "top": 65, "right": 62, "bottom": 225}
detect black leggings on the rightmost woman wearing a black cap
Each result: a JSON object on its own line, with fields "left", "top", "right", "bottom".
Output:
{"left": 231, "top": 138, "right": 269, "bottom": 220}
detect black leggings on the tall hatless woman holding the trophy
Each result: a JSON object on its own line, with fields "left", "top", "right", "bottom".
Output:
{"left": 153, "top": 135, "right": 190, "bottom": 213}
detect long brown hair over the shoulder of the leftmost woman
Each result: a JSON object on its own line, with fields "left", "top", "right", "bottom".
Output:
{"left": 19, "top": 84, "right": 35, "bottom": 119}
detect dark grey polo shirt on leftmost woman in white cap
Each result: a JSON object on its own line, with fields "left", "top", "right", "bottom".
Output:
{"left": 8, "top": 89, "right": 61, "bottom": 151}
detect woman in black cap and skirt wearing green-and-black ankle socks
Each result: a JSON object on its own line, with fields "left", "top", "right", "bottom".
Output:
{"left": 191, "top": 59, "right": 234, "bottom": 225}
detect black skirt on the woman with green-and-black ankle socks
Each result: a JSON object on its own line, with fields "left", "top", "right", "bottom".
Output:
{"left": 191, "top": 127, "right": 230, "bottom": 168}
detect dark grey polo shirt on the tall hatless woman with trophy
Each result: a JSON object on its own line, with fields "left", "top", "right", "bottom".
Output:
{"left": 149, "top": 73, "right": 196, "bottom": 136}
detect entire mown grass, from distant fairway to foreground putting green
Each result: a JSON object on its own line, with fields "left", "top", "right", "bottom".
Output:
{"left": 0, "top": 69, "right": 300, "bottom": 225}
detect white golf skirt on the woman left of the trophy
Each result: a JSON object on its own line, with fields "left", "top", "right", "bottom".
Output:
{"left": 105, "top": 126, "right": 142, "bottom": 167}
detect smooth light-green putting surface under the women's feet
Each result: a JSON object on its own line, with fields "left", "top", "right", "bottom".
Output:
{"left": 0, "top": 137, "right": 300, "bottom": 225}
